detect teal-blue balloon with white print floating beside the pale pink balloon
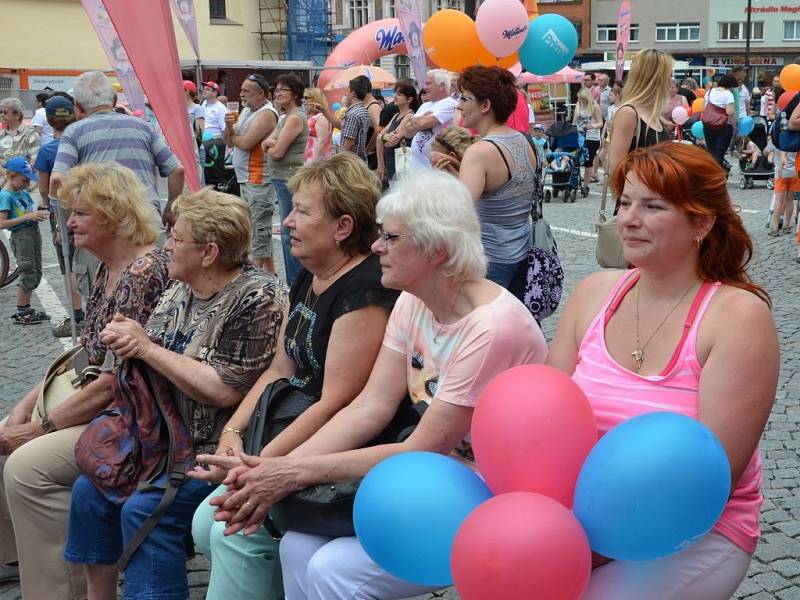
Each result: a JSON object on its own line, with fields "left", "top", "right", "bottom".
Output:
{"left": 519, "top": 13, "right": 578, "bottom": 75}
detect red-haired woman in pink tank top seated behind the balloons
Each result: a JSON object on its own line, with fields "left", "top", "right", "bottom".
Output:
{"left": 548, "top": 142, "right": 779, "bottom": 600}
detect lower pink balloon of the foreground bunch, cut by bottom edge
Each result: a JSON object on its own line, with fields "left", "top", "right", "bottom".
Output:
{"left": 450, "top": 492, "right": 592, "bottom": 600}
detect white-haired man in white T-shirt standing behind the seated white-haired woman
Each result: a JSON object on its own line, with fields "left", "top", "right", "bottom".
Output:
{"left": 402, "top": 69, "right": 457, "bottom": 169}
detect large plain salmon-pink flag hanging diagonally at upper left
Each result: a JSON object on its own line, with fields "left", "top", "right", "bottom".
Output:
{"left": 103, "top": 0, "right": 200, "bottom": 192}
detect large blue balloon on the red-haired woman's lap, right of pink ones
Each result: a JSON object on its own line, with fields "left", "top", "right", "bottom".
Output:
{"left": 573, "top": 412, "right": 731, "bottom": 560}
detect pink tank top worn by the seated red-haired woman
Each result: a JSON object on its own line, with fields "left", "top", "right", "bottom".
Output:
{"left": 572, "top": 270, "right": 762, "bottom": 554}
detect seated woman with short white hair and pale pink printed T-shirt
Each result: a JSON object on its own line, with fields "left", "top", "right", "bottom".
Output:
{"left": 197, "top": 170, "right": 547, "bottom": 600}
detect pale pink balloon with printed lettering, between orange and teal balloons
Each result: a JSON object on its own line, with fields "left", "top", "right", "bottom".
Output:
{"left": 475, "top": 0, "right": 528, "bottom": 58}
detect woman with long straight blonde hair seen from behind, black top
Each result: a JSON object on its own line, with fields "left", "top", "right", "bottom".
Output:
{"left": 608, "top": 48, "right": 674, "bottom": 173}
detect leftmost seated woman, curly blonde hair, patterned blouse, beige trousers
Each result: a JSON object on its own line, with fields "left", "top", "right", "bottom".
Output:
{"left": 0, "top": 162, "right": 170, "bottom": 600}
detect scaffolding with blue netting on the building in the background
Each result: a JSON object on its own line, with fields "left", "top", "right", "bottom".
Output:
{"left": 258, "top": 0, "right": 333, "bottom": 66}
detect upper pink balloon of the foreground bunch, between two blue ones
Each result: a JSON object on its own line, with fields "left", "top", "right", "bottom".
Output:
{"left": 472, "top": 365, "right": 597, "bottom": 508}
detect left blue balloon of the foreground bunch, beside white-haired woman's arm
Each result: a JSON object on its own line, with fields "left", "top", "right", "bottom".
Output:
{"left": 353, "top": 452, "right": 492, "bottom": 587}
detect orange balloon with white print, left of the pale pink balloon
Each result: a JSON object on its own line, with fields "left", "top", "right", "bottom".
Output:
{"left": 422, "top": 8, "right": 482, "bottom": 71}
